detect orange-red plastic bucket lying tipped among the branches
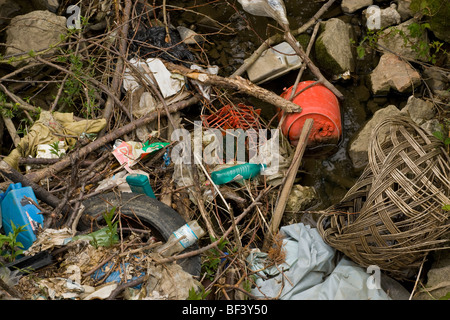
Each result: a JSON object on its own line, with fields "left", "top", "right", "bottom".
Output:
{"left": 280, "top": 81, "right": 342, "bottom": 147}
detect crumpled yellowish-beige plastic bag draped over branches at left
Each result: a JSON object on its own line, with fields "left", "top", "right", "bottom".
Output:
{"left": 4, "top": 110, "right": 106, "bottom": 170}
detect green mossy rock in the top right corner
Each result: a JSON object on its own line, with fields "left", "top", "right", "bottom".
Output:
{"left": 410, "top": 0, "right": 450, "bottom": 43}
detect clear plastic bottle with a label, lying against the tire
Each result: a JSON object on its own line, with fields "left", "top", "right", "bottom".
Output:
{"left": 156, "top": 220, "right": 205, "bottom": 257}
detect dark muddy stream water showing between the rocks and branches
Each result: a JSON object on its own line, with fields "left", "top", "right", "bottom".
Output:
{"left": 172, "top": 0, "right": 395, "bottom": 210}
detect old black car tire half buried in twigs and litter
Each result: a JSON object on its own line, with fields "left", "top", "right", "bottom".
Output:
{"left": 78, "top": 192, "right": 201, "bottom": 276}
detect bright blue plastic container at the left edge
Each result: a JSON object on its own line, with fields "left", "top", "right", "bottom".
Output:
{"left": 0, "top": 183, "right": 44, "bottom": 250}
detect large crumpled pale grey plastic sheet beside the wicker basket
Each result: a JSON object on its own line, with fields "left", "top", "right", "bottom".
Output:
{"left": 247, "top": 223, "right": 390, "bottom": 300}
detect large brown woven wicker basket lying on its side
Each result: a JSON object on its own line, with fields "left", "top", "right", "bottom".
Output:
{"left": 317, "top": 117, "right": 450, "bottom": 278}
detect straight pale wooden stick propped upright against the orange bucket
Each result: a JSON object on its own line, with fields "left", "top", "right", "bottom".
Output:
{"left": 262, "top": 119, "right": 314, "bottom": 252}
